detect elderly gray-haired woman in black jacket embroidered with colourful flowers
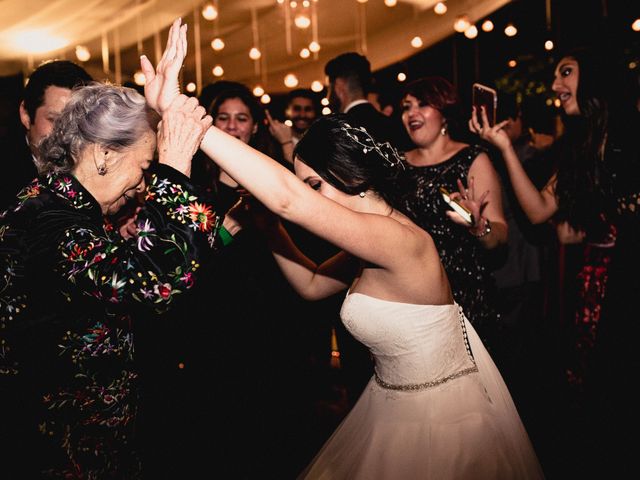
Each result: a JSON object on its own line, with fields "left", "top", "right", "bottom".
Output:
{"left": 0, "top": 21, "right": 220, "bottom": 479}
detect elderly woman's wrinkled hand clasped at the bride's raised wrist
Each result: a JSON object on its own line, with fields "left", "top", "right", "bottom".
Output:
{"left": 158, "top": 95, "right": 213, "bottom": 177}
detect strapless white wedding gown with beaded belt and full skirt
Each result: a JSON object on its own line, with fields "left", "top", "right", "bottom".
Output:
{"left": 299, "top": 293, "right": 544, "bottom": 480}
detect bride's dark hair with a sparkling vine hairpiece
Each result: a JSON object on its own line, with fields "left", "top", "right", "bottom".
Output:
{"left": 293, "top": 114, "right": 404, "bottom": 208}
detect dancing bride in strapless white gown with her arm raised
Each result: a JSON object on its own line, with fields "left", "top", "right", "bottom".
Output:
{"left": 142, "top": 37, "right": 543, "bottom": 480}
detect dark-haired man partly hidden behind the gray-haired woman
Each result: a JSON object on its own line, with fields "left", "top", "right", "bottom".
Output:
{"left": 0, "top": 60, "right": 92, "bottom": 210}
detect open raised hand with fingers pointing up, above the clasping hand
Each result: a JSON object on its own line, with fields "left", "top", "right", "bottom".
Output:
{"left": 140, "top": 18, "right": 187, "bottom": 114}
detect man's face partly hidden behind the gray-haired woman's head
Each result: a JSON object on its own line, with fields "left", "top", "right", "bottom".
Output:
{"left": 20, "top": 85, "right": 71, "bottom": 156}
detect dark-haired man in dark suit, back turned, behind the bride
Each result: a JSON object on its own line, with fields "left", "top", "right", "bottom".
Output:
{"left": 324, "top": 52, "right": 414, "bottom": 151}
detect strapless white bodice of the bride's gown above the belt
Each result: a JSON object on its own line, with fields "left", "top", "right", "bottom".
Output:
{"left": 340, "top": 293, "right": 475, "bottom": 385}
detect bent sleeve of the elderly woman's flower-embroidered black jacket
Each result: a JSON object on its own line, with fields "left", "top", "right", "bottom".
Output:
{"left": 56, "top": 165, "right": 224, "bottom": 312}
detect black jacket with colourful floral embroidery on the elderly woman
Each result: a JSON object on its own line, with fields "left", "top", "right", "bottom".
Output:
{"left": 0, "top": 165, "right": 216, "bottom": 479}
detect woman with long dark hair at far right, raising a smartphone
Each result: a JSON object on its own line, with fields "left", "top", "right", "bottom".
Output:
{"left": 469, "top": 48, "right": 640, "bottom": 476}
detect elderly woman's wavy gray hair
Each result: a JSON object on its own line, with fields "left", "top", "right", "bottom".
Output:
{"left": 36, "top": 82, "right": 159, "bottom": 174}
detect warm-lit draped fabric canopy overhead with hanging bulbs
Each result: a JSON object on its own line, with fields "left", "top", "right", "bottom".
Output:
{"left": 0, "top": 0, "right": 509, "bottom": 92}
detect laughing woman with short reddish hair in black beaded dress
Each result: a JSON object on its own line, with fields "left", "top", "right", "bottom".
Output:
{"left": 402, "top": 77, "right": 507, "bottom": 350}
